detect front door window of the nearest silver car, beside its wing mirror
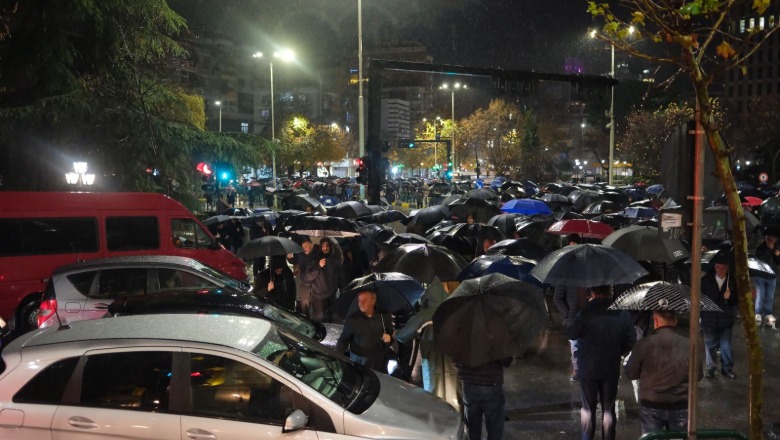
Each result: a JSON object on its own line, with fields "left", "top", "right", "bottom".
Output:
{"left": 190, "top": 353, "right": 295, "bottom": 425}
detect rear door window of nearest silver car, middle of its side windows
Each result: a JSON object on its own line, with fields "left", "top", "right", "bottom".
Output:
{"left": 80, "top": 351, "right": 173, "bottom": 412}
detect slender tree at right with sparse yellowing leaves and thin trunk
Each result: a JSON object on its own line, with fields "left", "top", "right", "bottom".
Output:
{"left": 588, "top": 0, "right": 778, "bottom": 439}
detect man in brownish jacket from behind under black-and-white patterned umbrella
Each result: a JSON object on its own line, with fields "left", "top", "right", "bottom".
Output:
{"left": 624, "top": 310, "right": 703, "bottom": 434}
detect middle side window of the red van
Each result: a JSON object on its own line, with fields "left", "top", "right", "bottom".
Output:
{"left": 106, "top": 217, "right": 160, "bottom": 251}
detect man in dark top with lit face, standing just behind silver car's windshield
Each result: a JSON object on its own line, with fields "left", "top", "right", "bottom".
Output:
{"left": 336, "top": 290, "right": 394, "bottom": 374}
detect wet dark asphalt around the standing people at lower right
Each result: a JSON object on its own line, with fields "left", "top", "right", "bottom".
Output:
{"left": 504, "top": 310, "right": 780, "bottom": 439}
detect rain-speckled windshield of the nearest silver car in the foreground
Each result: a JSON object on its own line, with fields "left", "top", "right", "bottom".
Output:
{"left": 252, "top": 327, "right": 373, "bottom": 409}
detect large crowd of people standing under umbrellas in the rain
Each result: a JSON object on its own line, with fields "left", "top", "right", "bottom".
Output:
{"left": 201, "top": 178, "right": 780, "bottom": 439}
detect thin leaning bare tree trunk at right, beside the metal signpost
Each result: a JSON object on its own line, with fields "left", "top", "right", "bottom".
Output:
{"left": 694, "top": 80, "right": 764, "bottom": 440}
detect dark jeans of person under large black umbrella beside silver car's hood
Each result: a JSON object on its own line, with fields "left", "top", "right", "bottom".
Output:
{"left": 463, "top": 383, "right": 506, "bottom": 440}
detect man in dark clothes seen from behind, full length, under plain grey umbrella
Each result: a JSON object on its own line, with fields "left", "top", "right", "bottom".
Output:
{"left": 566, "top": 286, "right": 636, "bottom": 440}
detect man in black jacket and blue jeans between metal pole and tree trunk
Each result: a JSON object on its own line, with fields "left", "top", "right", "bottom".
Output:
{"left": 701, "top": 259, "right": 739, "bottom": 379}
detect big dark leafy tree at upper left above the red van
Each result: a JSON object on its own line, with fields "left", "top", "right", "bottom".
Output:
{"left": 0, "top": 0, "right": 263, "bottom": 207}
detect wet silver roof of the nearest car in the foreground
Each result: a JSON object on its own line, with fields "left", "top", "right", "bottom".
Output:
{"left": 12, "top": 313, "right": 277, "bottom": 351}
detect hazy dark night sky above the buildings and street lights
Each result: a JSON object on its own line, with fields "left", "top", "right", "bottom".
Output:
{"left": 169, "top": 0, "right": 596, "bottom": 73}
